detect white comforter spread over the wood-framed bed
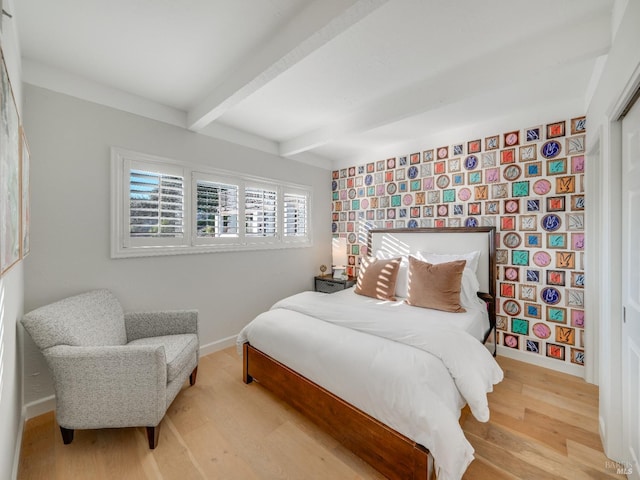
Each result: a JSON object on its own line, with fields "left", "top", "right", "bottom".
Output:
{"left": 237, "top": 290, "right": 503, "bottom": 480}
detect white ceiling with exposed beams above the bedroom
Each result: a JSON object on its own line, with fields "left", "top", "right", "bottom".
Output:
{"left": 14, "top": 0, "right": 613, "bottom": 168}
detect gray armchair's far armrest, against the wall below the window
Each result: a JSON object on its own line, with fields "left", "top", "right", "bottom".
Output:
{"left": 124, "top": 310, "right": 198, "bottom": 342}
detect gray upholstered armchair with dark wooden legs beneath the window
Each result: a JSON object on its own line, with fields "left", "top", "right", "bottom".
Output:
{"left": 22, "top": 290, "right": 199, "bottom": 449}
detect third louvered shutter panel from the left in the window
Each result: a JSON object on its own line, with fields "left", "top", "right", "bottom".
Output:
{"left": 244, "top": 187, "right": 278, "bottom": 237}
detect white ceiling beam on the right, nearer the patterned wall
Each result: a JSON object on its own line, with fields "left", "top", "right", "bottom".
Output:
{"left": 280, "top": 10, "right": 610, "bottom": 156}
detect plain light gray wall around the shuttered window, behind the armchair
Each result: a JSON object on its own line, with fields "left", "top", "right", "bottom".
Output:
{"left": 24, "top": 85, "right": 331, "bottom": 406}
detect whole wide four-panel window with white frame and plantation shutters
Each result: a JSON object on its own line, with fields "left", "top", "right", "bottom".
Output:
{"left": 111, "top": 148, "right": 311, "bottom": 258}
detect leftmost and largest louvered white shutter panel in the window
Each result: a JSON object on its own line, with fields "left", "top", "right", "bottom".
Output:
{"left": 129, "top": 169, "right": 184, "bottom": 238}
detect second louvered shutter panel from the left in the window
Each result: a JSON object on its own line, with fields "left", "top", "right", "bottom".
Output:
{"left": 196, "top": 180, "right": 239, "bottom": 238}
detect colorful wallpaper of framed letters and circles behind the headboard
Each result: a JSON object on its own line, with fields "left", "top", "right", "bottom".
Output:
{"left": 331, "top": 117, "right": 586, "bottom": 365}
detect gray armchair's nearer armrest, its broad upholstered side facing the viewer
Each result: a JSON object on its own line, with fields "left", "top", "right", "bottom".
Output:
{"left": 44, "top": 345, "right": 167, "bottom": 429}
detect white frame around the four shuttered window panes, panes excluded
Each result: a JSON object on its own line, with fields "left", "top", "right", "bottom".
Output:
{"left": 111, "top": 147, "right": 312, "bottom": 258}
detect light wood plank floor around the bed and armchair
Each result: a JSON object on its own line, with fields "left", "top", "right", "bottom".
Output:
{"left": 18, "top": 348, "right": 624, "bottom": 480}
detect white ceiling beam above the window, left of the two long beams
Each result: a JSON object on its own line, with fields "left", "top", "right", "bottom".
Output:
{"left": 187, "top": 0, "right": 388, "bottom": 131}
